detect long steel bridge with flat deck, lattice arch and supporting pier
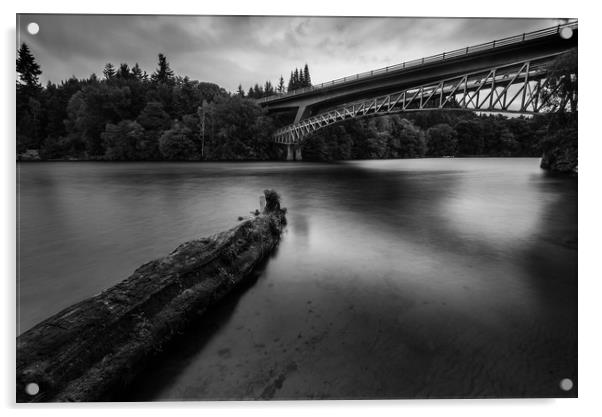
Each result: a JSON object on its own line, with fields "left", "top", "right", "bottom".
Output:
{"left": 257, "top": 22, "right": 578, "bottom": 160}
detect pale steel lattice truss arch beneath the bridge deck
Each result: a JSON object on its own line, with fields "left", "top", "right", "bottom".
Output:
{"left": 274, "top": 55, "right": 568, "bottom": 145}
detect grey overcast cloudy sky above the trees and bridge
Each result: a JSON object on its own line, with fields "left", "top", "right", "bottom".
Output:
{"left": 17, "top": 15, "right": 563, "bottom": 91}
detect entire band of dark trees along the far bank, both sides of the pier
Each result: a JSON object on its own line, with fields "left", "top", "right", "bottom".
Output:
{"left": 17, "top": 44, "right": 577, "bottom": 172}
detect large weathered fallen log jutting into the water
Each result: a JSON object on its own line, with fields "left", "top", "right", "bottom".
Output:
{"left": 17, "top": 190, "right": 286, "bottom": 402}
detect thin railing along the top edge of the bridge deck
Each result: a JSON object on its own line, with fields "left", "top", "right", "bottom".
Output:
{"left": 257, "top": 22, "right": 578, "bottom": 103}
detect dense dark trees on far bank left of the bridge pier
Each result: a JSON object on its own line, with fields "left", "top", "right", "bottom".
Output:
{"left": 17, "top": 44, "right": 282, "bottom": 160}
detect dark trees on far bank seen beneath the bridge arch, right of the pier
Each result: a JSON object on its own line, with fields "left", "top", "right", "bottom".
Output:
{"left": 303, "top": 111, "right": 577, "bottom": 167}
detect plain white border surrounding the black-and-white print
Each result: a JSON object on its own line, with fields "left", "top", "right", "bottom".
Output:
{"left": 0, "top": 0, "right": 602, "bottom": 417}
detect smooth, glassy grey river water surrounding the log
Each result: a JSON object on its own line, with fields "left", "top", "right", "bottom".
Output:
{"left": 17, "top": 158, "right": 577, "bottom": 401}
